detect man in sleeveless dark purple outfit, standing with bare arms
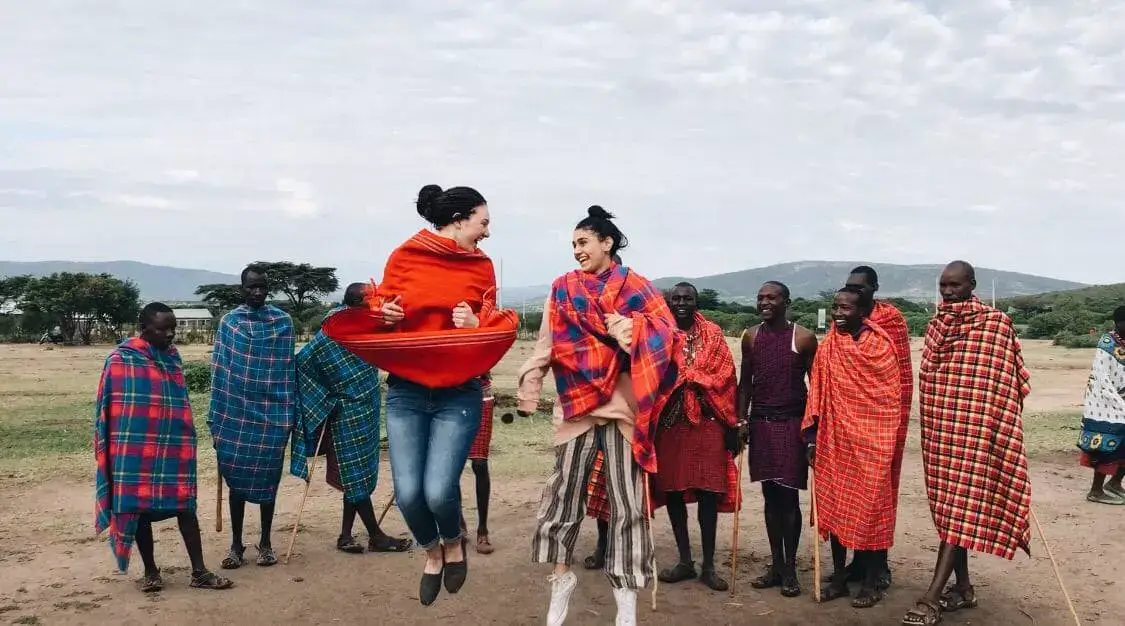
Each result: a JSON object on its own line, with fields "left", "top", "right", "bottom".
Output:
{"left": 738, "top": 280, "right": 817, "bottom": 598}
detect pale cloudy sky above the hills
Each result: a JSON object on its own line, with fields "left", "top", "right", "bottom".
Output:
{"left": 0, "top": 0, "right": 1125, "bottom": 286}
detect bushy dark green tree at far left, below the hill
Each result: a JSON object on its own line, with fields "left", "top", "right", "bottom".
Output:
{"left": 23, "top": 271, "right": 141, "bottom": 345}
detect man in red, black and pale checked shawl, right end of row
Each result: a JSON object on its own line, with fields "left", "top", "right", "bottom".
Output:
{"left": 902, "top": 261, "right": 1032, "bottom": 625}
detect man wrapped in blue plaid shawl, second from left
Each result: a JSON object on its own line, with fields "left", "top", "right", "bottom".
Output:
{"left": 207, "top": 265, "right": 297, "bottom": 570}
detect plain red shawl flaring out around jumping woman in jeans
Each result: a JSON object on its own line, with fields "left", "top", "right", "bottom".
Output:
{"left": 323, "top": 230, "right": 520, "bottom": 388}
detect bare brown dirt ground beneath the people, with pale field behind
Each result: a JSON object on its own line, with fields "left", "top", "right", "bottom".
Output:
{"left": 0, "top": 342, "right": 1125, "bottom": 625}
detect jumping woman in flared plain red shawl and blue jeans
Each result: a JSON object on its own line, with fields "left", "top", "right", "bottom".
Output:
{"left": 324, "top": 185, "right": 519, "bottom": 606}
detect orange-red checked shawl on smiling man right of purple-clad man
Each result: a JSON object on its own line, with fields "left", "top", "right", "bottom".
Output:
{"left": 801, "top": 320, "right": 902, "bottom": 549}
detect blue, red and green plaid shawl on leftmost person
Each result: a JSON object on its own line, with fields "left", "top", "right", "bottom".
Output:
{"left": 93, "top": 339, "right": 197, "bottom": 572}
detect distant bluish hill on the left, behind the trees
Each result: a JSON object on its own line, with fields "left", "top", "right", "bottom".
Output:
{"left": 0, "top": 261, "right": 239, "bottom": 301}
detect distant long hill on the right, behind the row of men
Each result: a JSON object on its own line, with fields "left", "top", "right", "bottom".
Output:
{"left": 504, "top": 261, "right": 1086, "bottom": 306}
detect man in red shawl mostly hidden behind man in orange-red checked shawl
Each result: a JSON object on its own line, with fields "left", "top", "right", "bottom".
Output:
{"left": 845, "top": 266, "right": 914, "bottom": 590}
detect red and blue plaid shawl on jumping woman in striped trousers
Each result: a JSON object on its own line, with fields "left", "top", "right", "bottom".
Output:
{"left": 549, "top": 265, "right": 684, "bottom": 474}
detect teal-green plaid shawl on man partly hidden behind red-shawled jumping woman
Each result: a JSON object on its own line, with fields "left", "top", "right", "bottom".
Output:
{"left": 289, "top": 314, "right": 380, "bottom": 502}
